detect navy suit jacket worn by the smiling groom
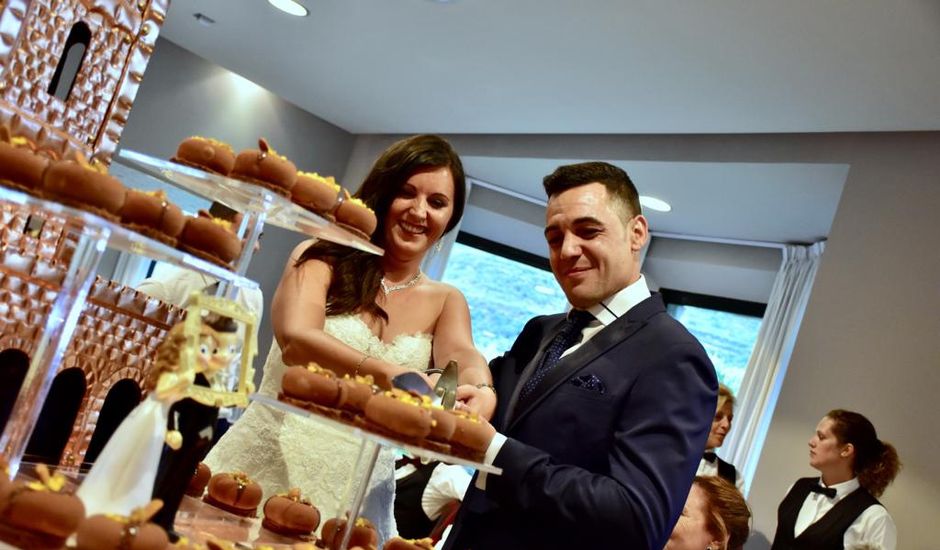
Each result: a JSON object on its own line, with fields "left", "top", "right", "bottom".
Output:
{"left": 445, "top": 293, "right": 718, "bottom": 550}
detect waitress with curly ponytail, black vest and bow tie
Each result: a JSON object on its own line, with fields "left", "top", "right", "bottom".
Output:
{"left": 771, "top": 409, "right": 901, "bottom": 550}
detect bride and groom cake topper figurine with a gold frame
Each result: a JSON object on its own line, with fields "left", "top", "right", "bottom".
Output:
{"left": 76, "top": 295, "right": 256, "bottom": 516}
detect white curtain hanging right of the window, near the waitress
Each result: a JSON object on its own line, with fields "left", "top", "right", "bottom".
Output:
{"left": 719, "top": 242, "right": 825, "bottom": 495}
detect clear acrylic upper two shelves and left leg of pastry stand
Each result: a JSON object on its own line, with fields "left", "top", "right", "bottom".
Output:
{"left": 0, "top": 151, "right": 382, "bottom": 475}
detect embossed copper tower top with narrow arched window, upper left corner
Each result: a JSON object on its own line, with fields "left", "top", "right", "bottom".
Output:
{"left": 0, "top": 0, "right": 169, "bottom": 163}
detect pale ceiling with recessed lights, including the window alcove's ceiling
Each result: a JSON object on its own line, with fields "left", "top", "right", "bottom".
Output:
{"left": 156, "top": 0, "right": 940, "bottom": 246}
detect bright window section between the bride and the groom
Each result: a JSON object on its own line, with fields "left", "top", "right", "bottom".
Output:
{"left": 441, "top": 233, "right": 568, "bottom": 360}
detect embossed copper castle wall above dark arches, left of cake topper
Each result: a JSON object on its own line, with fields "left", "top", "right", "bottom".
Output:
{"left": 0, "top": 203, "right": 184, "bottom": 466}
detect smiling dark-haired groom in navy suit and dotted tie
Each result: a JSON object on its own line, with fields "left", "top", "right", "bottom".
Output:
{"left": 445, "top": 162, "right": 718, "bottom": 550}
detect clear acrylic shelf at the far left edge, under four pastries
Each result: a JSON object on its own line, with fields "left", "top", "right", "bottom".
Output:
{"left": 0, "top": 186, "right": 258, "bottom": 288}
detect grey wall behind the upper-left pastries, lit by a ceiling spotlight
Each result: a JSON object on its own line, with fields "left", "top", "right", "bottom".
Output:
{"left": 121, "top": 39, "right": 354, "bottom": 373}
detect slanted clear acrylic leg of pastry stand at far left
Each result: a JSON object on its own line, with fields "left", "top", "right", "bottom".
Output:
{"left": 0, "top": 220, "right": 111, "bottom": 477}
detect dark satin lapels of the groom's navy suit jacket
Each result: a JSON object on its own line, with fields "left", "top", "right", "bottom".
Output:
{"left": 506, "top": 295, "right": 665, "bottom": 432}
